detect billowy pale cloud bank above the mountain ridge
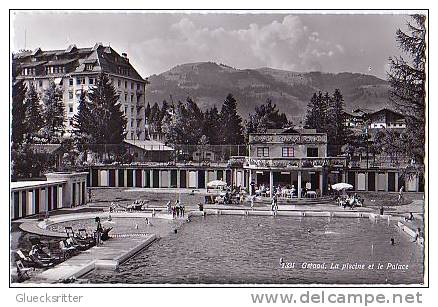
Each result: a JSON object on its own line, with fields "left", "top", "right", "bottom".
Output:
{"left": 130, "top": 16, "right": 344, "bottom": 72}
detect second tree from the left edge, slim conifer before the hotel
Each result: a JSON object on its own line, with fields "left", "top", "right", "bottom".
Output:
{"left": 24, "top": 83, "right": 44, "bottom": 142}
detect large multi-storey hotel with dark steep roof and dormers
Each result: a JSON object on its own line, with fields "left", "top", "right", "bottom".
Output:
{"left": 12, "top": 43, "right": 146, "bottom": 140}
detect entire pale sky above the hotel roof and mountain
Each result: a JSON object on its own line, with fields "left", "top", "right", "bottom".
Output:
{"left": 11, "top": 11, "right": 409, "bottom": 78}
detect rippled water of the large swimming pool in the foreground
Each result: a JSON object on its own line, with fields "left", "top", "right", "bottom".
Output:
{"left": 85, "top": 216, "right": 423, "bottom": 284}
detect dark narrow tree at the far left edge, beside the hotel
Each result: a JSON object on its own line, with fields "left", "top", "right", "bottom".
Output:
{"left": 12, "top": 81, "right": 26, "bottom": 148}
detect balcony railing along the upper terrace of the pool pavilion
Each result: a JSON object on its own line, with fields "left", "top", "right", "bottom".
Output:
{"left": 244, "top": 157, "right": 347, "bottom": 169}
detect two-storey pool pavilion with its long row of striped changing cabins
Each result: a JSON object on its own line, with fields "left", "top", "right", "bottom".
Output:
{"left": 87, "top": 128, "right": 424, "bottom": 197}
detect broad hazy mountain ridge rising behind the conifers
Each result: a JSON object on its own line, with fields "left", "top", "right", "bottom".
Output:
{"left": 146, "top": 62, "right": 389, "bottom": 118}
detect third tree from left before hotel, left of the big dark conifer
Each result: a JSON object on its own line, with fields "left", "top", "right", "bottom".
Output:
{"left": 42, "top": 80, "right": 65, "bottom": 143}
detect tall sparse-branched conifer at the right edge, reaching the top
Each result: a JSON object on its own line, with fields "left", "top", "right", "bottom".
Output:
{"left": 388, "top": 15, "right": 426, "bottom": 164}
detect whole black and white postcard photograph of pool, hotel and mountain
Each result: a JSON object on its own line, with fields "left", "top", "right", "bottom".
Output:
{"left": 5, "top": 10, "right": 429, "bottom": 288}
